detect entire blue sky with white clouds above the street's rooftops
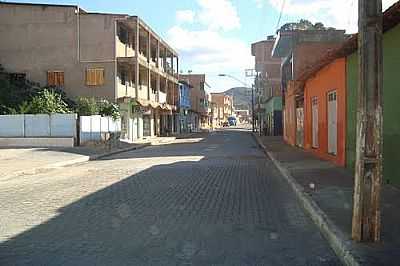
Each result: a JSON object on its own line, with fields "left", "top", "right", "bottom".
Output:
{"left": 8, "top": 0, "right": 397, "bottom": 92}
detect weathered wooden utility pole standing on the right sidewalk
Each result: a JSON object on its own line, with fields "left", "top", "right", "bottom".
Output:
{"left": 352, "top": 0, "right": 383, "bottom": 242}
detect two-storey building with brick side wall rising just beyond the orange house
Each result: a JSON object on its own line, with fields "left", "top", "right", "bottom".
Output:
{"left": 272, "top": 30, "right": 346, "bottom": 147}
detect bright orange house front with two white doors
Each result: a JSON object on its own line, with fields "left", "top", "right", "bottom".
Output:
{"left": 304, "top": 57, "right": 346, "bottom": 166}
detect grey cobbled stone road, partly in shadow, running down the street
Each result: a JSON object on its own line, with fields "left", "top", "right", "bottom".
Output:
{"left": 0, "top": 130, "right": 339, "bottom": 265}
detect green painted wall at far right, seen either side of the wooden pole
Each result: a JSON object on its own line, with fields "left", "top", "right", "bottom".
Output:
{"left": 346, "top": 24, "right": 400, "bottom": 185}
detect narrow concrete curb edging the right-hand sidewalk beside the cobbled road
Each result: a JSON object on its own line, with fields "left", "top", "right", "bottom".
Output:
{"left": 252, "top": 134, "right": 362, "bottom": 266}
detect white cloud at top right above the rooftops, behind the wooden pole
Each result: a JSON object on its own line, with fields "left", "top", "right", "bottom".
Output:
{"left": 269, "top": 0, "right": 397, "bottom": 32}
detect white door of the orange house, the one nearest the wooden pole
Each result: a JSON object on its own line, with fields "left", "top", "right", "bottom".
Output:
{"left": 328, "top": 91, "right": 337, "bottom": 155}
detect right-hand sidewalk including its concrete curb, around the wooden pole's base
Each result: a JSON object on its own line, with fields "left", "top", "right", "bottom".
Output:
{"left": 256, "top": 136, "right": 400, "bottom": 265}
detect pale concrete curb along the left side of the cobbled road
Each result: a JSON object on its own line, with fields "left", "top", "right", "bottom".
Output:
{"left": 0, "top": 143, "right": 151, "bottom": 182}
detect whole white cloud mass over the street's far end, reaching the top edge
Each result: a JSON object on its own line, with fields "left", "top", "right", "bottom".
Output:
{"left": 167, "top": 0, "right": 250, "bottom": 91}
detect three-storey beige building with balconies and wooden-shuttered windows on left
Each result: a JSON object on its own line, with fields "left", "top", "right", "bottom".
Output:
{"left": 0, "top": 2, "right": 179, "bottom": 141}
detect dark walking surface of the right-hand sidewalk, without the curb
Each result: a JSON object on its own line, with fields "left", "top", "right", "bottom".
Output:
{"left": 259, "top": 137, "right": 400, "bottom": 266}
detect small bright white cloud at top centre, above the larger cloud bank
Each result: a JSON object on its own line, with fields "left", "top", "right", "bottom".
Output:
{"left": 197, "top": 0, "right": 240, "bottom": 31}
